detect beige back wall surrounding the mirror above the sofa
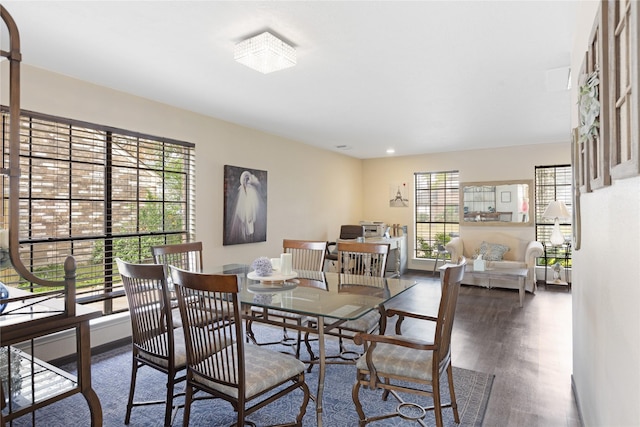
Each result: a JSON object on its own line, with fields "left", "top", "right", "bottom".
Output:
{"left": 363, "top": 145, "right": 571, "bottom": 270}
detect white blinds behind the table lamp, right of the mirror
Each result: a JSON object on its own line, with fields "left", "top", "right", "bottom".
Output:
{"left": 535, "top": 165, "right": 573, "bottom": 246}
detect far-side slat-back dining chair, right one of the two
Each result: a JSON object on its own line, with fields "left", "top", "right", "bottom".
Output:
{"left": 304, "top": 242, "right": 390, "bottom": 372}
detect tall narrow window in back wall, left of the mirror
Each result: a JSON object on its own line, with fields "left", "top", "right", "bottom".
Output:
{"left": 415, "top": 171, "right": 460, "bottom": 258}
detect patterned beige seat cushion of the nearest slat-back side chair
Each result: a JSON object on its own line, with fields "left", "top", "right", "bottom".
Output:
{"left": 193, "top": 345, "right": 305, "bottom": 399}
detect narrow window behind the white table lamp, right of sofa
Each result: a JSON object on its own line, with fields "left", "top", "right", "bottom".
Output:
{"left": 535, "top": 165, "right": 573, "bottom": 267}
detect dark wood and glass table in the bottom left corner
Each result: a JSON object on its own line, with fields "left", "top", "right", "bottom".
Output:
{"left": 0, "top": 288, "right": 102, "bottom": 427}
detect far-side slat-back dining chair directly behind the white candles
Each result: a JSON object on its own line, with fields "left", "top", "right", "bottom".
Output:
{"left": 246, "top": 239, "right": 327, "bottom": 358}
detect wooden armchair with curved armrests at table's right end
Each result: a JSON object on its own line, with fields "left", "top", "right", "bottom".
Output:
{"left": 352, "top": 258, "right": 466, "bottom": 427}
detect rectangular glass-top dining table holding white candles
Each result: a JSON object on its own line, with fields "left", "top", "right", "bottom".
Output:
{"left": 203, "top": 264, "right": 416, "bottom": 426}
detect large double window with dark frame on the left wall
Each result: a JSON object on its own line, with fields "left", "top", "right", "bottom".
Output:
{"left": 0, "top": 109, "right": 195, "bottom": 314}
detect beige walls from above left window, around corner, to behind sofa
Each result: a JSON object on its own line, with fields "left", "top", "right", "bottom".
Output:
{"left": 2, "top": 64, "right": 570, "bottom": 269}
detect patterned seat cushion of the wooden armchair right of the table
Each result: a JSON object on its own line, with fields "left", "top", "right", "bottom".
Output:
{"left": 356, "top": 336, "right": 433, "bottom": 381}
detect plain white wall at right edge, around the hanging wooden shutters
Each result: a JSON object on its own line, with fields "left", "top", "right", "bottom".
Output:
{"left": 559, "top": 1, "right": 640, "bottom": 427}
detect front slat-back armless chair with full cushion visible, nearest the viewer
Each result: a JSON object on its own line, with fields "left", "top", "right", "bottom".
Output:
{"left": 170, "top": 266, "right": 309, "bottom": 426}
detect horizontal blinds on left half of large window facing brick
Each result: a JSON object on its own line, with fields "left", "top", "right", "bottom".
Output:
{"left": 13, "top": 115, "right": 105, "bottom": 296}
